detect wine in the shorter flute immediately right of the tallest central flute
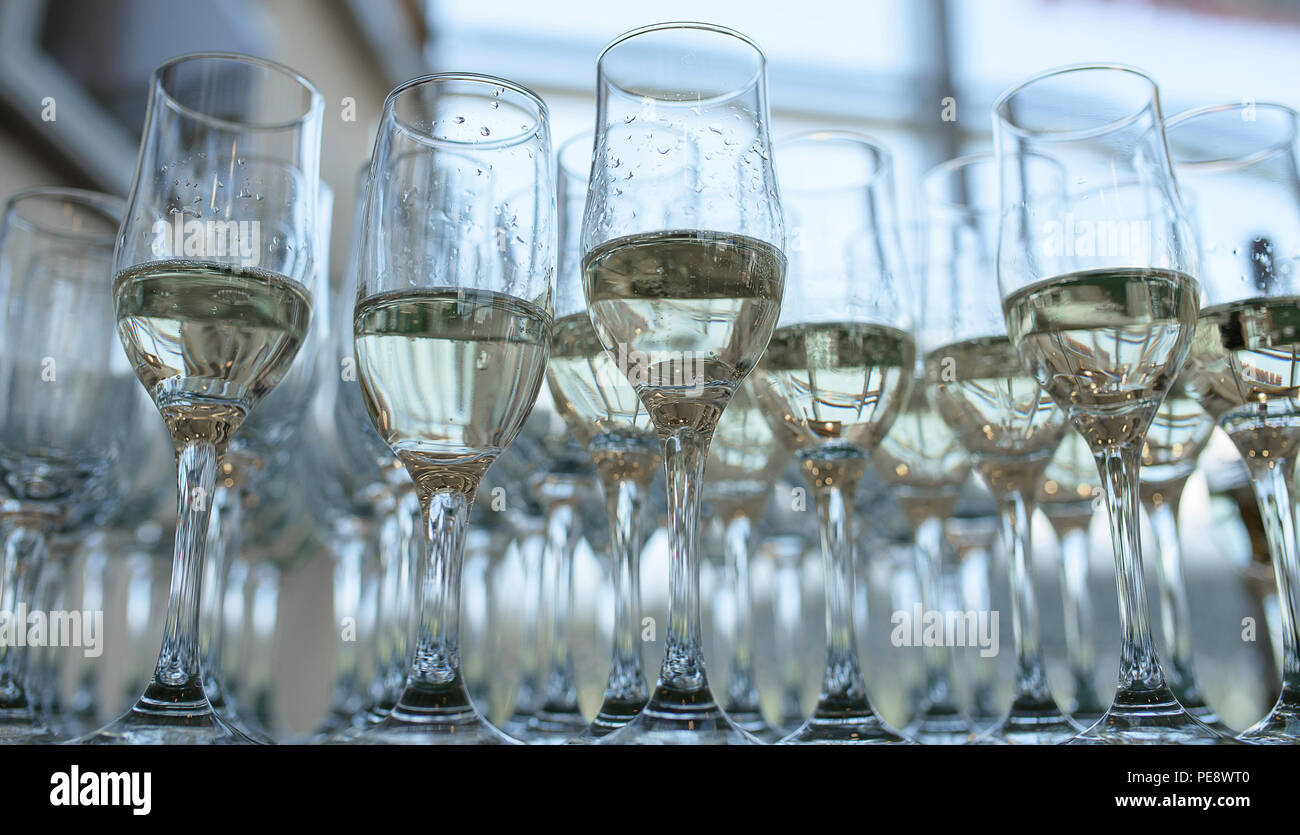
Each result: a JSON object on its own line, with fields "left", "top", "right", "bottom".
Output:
{"left": 757, "top": 317, "right": 917, "bottom": 453}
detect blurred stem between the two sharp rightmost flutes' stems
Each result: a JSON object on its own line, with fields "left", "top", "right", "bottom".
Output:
{"left": 1144, "top": 483, "right": 1201, "bottom": 705}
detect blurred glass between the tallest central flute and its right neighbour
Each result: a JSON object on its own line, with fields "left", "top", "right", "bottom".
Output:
{"left": 705, "top": 380, "right": 792, "bottom": 743}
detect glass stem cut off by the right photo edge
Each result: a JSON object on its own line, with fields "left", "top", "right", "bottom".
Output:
{"left": 1247, "top": 458, "right": 1300, "bottom": 708}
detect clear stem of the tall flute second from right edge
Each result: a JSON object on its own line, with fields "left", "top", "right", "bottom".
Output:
{"left": 1096, "top": 444, "right": 1166, "bottom": 693}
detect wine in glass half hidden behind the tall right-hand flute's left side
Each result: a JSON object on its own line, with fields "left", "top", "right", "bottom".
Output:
{"left": 926, "top": 336, "right": 1066, "bottom": 496}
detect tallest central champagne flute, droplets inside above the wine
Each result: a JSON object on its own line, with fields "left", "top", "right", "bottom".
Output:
{"left": 582, "top": 23, "right": 785, "bottom": 744}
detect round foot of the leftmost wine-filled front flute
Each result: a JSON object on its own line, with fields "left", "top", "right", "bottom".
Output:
{"left": 69, "top": 684, "right": 257, "bottom": 745}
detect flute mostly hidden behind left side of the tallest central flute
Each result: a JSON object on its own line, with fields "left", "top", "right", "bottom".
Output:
{"left": 546, "top": 128, "right": 659, "bottom": 741}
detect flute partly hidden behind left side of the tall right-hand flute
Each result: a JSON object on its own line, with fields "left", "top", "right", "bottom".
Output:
{"left": 920, "top": 153, "right": 1079, "bottom": 745}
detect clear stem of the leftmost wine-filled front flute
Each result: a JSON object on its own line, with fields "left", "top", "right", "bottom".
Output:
{"left": 146, "top": 441, "right": 217, "bottom": 702}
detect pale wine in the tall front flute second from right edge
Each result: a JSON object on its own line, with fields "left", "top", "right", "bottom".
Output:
{"left": 1004, "top": 268, "right": 1197, "bottom": 449}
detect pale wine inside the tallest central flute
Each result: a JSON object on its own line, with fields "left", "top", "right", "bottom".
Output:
{"left": 582, "top": 230, "right": 785, "bottom": 432}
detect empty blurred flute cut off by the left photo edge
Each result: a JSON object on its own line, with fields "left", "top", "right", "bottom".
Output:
{"left": 0, "top": 189, "right": 143, "bottom": 744}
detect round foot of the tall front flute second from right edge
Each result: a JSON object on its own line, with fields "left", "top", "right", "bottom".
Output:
{"left": 1066, "top": 687, "right": 1239, "bottom": 745}
